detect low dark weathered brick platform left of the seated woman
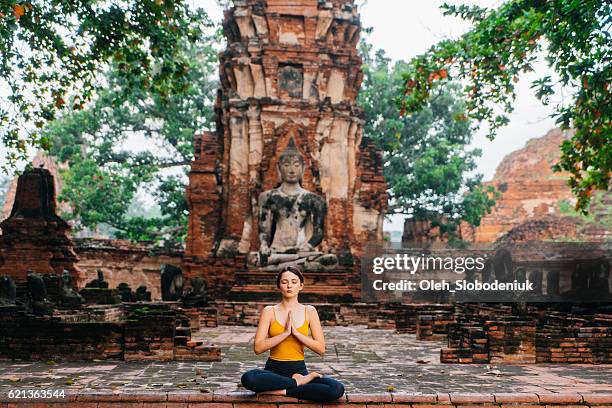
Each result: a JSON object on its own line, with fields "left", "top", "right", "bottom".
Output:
{"left": 0, "top": 302, "right": 221, "bottom": 361}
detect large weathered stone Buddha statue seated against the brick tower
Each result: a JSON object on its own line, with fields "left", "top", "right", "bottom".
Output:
{"left": 250, "top": 138, "right": 338, "bottom": 270}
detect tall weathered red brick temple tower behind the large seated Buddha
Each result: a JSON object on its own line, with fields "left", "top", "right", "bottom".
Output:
{"left": 184, "top": 0, "right": 387, "bottom": 302}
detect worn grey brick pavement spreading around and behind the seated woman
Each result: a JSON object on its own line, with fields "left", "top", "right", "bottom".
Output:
{"left": 0, "top": 326, "right": 612, "bottom": 408}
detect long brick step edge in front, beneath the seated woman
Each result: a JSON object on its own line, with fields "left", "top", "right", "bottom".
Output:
{"left": 27, "top": 388, "right": 612, "bottom": 408}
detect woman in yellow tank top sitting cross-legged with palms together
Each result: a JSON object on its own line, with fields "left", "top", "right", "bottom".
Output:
{"left": 241, "top": 266, "right": 344, "bottom": 402}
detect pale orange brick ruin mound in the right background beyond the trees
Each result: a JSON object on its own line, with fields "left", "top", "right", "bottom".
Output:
{"left": 461, "top": 129, "right": 612, "bottom": 243}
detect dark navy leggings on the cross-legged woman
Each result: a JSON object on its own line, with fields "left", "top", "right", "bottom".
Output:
{"left": 240, "top": 358, "right": 344, "bottom": 402}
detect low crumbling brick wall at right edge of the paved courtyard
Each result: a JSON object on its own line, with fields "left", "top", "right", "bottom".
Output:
{"left": 440, "top": 304, "right": 612, "bottom": 364}
